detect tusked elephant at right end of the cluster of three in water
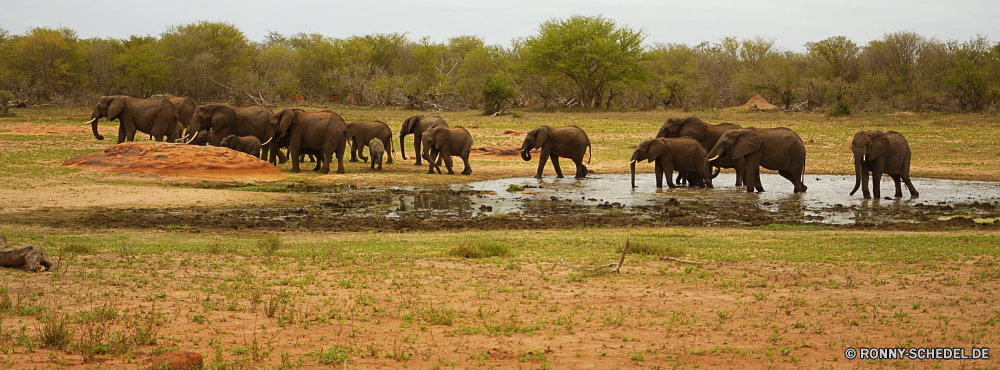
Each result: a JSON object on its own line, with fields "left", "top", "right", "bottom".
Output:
{"left": 708, "top": 127, "right": 807, "bottom": 193}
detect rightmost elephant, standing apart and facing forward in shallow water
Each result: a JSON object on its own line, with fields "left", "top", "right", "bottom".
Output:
{"left": 851, "top": 130, "right": 920, "bottom": 199}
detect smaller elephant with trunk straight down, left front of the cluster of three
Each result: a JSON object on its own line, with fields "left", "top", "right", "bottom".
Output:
{"left": 629, "top": 137, "right": 712, "bottom": 189}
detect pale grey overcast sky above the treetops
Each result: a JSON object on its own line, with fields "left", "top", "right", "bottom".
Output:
{"left": 0, "top": 0, "right": 1000, "bottom": 51}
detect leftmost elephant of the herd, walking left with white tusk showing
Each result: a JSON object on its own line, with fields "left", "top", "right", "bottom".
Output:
{"left": 86, "top": 95, "right": 181, "bottom": 144}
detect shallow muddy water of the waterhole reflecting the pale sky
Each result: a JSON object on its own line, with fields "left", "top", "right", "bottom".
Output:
{"left": 452, "top": 174, "right": 1000, "bottom": 224}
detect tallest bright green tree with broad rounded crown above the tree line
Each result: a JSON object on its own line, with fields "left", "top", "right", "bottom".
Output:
{"left": 524, "top": 15, "right": 646, "bottom": 108}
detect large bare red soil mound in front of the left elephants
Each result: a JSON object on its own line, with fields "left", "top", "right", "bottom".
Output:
{"left": 63, "top": 142, "right": 285, "bottom": 180}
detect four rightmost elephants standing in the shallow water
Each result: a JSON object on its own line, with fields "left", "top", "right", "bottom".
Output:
{"left": 630, "top": 117, "right": 919, "bottom": 199}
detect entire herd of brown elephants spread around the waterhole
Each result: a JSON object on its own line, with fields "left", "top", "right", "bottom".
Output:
{"left": 87, "top": 94, "right": 919, "bottom": 199}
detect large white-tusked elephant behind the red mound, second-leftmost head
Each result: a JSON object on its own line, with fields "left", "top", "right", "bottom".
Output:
{"left": 187, "top": 104, "right": 284, "bottom": 159}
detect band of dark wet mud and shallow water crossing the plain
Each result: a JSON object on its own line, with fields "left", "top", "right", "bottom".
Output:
{"left": 13, "top": 174, "right": 1000, "bottom": 232}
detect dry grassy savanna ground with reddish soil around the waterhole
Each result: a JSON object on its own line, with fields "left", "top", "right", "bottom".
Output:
{"left": 0, "top": 107, "right": 1000, "bottom": 369}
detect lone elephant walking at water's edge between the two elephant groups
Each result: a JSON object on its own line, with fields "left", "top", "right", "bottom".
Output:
{"left": 521, "top": 125, "right": 594, "bottom": 179}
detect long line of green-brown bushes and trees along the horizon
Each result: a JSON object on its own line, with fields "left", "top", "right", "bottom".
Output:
{"left": 0, "top": 16, "right": 1000, "bottom": 114}
